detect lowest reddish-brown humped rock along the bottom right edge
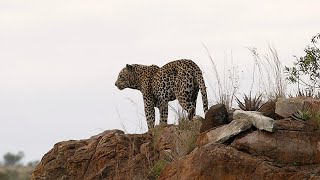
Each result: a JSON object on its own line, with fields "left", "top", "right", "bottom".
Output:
{"left": 158, "top": 143, "right": 320, "bottom": 180}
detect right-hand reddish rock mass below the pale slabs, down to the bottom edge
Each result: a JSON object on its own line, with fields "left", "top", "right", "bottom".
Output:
{"left": 159, "top": 120, "right": 320, "bottom": 180}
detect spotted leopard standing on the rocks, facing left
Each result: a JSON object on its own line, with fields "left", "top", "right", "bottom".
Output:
{"left": 115, "top": 59, "right": 208, "bottom": 129}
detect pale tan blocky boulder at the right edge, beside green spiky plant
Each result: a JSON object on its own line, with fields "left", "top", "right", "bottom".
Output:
{"left": 275, "top": 97, "right": 320, "bottom": 118}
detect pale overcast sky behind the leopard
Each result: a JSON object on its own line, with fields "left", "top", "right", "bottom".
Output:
{"left": 0, "top": 0, "right": 320, "bottom": 162}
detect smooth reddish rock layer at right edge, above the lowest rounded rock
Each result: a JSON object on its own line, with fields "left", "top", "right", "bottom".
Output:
{"left": 231, "top": 130, "right": 320, "bottom": 164}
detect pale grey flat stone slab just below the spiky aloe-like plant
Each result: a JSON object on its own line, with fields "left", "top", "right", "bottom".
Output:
{"left": 233, "top": 110, "right": 275, "bottom": 132}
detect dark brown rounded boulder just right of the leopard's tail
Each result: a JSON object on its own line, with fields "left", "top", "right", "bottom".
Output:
{"left": 200, "top": 104, "right": 228, "bottom": 133}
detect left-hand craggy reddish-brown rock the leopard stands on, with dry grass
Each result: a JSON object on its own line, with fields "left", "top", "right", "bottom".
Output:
{"left": 31, "top": 124, "right": 199, "bottom": 180}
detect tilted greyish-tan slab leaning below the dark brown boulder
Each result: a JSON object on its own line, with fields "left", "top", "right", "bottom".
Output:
{"left": 197, "top": 119, "right": 252, "bottom": 147}
